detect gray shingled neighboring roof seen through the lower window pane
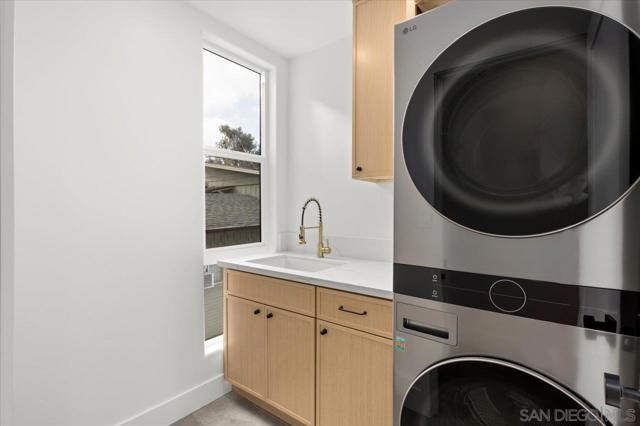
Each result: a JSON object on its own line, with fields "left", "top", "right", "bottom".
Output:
{"left": 205, "top": 192, "right": 260, "bottom": 231}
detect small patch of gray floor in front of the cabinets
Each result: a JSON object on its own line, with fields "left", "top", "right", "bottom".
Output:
{"left": 173, "top": 392, "right": 286, "bottom": 426}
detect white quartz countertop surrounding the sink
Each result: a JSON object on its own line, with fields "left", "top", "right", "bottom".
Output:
{"left": 217, "top": 252, "right": 393, "bottom": 300}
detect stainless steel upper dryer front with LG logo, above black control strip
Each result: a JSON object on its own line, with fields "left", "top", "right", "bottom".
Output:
{"left": 394, "top": 0, "right": 640, "bottom": 291}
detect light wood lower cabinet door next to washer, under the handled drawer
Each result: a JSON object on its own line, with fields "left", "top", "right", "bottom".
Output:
{"left": 316, "top": 321, "right": 393, "bottom": 426}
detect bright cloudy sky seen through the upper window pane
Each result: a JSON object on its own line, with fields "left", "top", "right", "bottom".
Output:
{"left": 203, "top": 50, "right": 260, "bottom": 153}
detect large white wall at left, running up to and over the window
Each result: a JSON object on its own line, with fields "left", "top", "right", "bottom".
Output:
{"left": 13, "top": 0, "right": 287, "bottom": 426}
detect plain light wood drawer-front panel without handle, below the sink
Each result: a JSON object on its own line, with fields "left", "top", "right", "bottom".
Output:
{"left": 225, "top": 269, "right": 316, "bottom": 316}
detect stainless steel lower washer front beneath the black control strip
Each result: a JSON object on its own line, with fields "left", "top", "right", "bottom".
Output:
{"left": 394, "top": 294, "right": 640, "bottom": 426}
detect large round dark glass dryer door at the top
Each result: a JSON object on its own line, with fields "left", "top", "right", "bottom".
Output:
{"left": 402, "top": 7, "right": 640, "bottom": 236}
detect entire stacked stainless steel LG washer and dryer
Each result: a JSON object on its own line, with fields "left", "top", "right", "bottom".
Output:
{"left": 394, "top": 0, "right": 640, "bottom": 426}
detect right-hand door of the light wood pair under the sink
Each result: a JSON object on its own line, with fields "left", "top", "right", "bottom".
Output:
{"left": 266, "top": 307, "right": 315, "bottom": 425}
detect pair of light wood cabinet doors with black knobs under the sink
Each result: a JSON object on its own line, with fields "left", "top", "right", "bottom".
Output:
{"left": 224, "top": 294, "right": 315, "bottom": 426}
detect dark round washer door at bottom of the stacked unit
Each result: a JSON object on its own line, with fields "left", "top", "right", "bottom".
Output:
{"left": 400, "top": 358, "right": 603, "bottom": 426}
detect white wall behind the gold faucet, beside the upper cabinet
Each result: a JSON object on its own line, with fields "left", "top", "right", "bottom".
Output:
{"left": 284, "top": 38, "right": 393, "bottom": 260}
